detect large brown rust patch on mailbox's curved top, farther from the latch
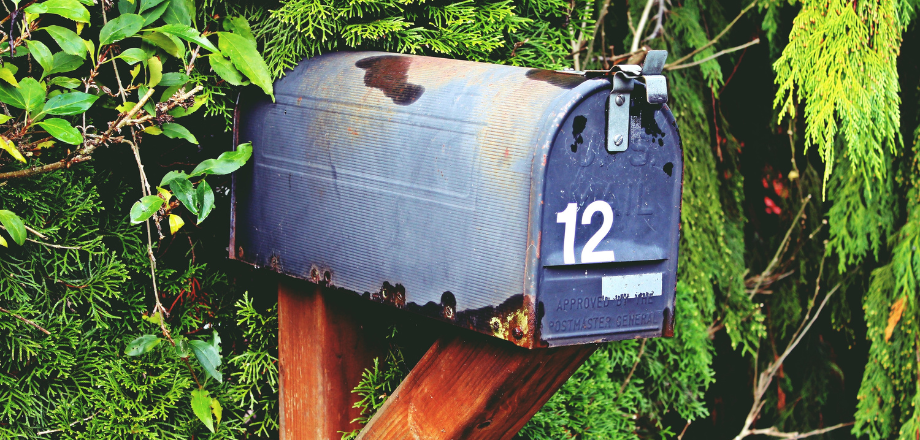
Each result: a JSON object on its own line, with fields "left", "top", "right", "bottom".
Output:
{"left": 355, "top": 55, "right": 425, "bottom": 105}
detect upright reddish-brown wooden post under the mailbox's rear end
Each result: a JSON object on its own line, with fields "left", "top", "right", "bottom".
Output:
{"left": 278, "top": 278, "right": 387, "bottom": 440}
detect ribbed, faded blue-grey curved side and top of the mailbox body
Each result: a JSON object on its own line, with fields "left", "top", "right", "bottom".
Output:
{"left": 235, "top": 52, "right": 606, "bottom": 311}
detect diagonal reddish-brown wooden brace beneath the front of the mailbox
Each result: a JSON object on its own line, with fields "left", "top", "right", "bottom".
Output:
{"left": 358, "top": 332, "right": 597, "bottom": 440}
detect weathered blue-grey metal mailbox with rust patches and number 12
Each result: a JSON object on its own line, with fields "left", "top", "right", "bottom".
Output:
{"left": 230, "top": 52, "right": 683, "bottom": 348}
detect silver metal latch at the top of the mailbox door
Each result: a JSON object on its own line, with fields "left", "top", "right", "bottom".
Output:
{"left": 607, "top": 50, "right": 668, "bottom": 153}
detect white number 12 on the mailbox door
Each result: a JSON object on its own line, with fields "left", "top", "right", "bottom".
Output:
{"left": 556, "top": 200, "right": 613, "bottom": 264}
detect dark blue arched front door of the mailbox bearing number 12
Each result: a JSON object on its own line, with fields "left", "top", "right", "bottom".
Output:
{"left": 537, "top": 85, "right": 683, "bottom": 346}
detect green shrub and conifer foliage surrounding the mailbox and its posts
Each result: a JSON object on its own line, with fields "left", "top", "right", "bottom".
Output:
{"left": 0, "top": 0, "right": 920, "bottom": 440}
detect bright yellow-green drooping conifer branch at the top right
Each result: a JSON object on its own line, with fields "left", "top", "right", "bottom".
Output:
{"left": 773, "top": 0, "right": 908, "bottom": 194}
